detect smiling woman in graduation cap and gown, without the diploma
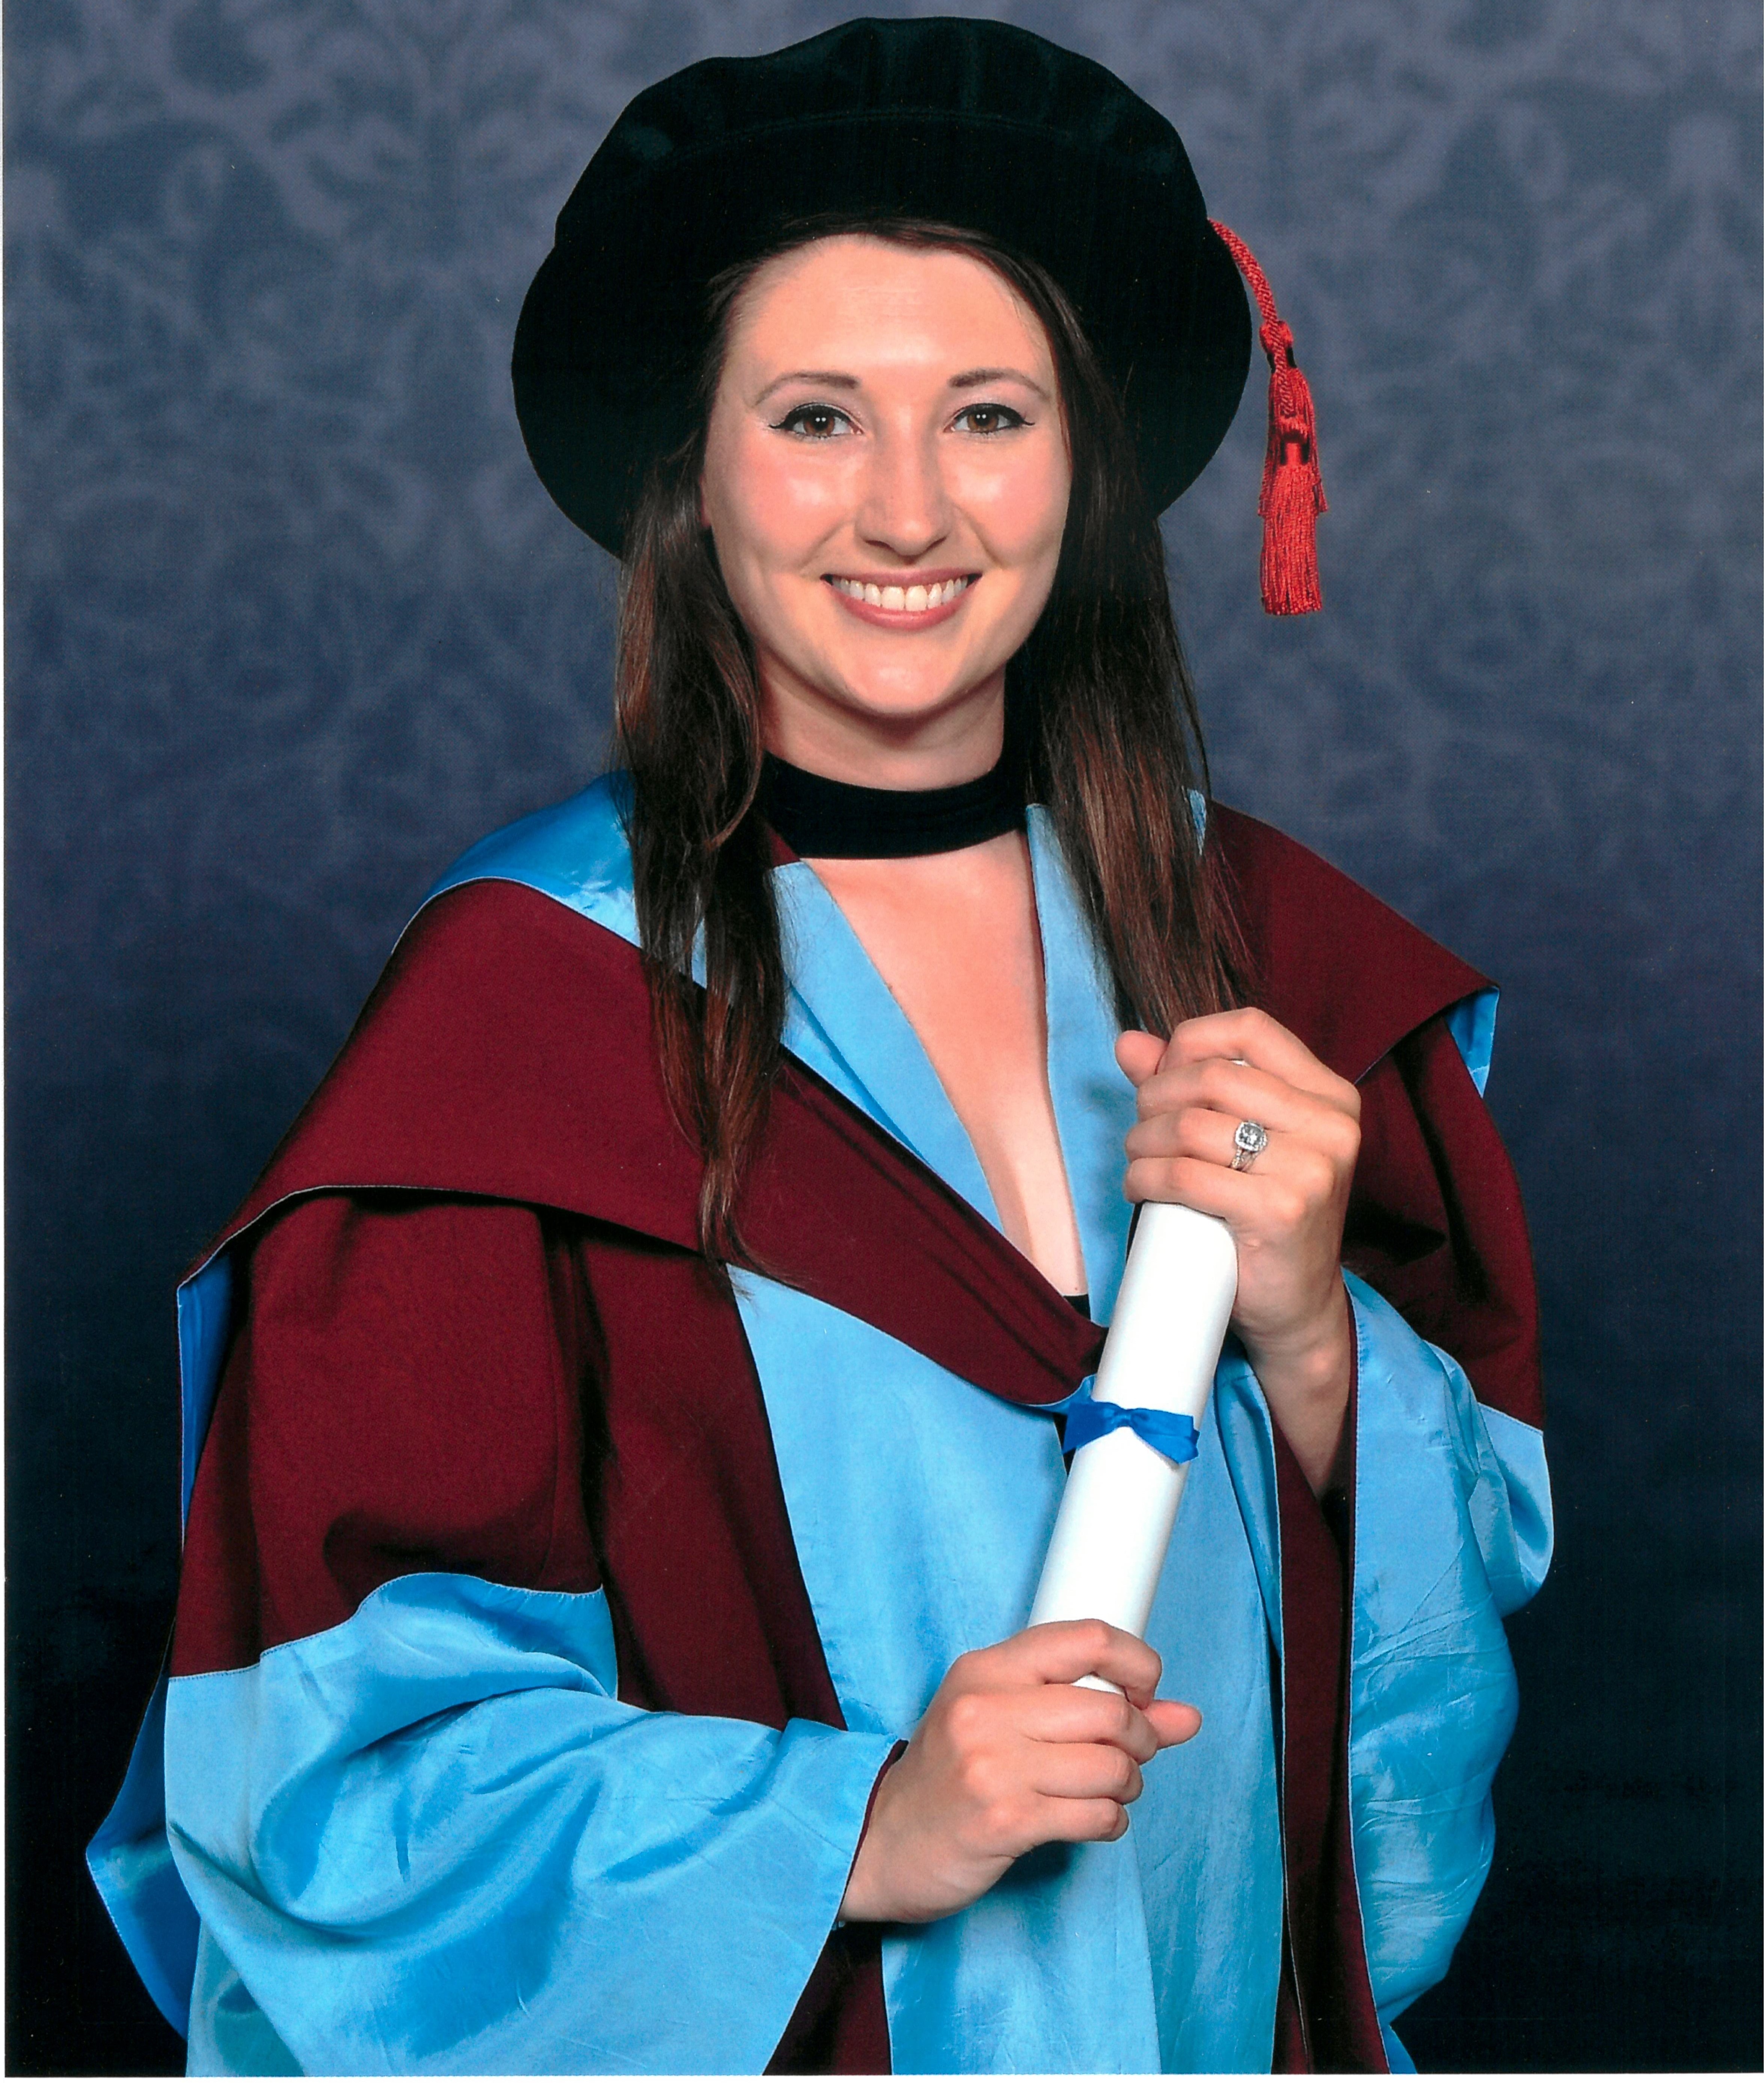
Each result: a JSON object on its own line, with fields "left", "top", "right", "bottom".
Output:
{"left": 94, "top": 21, "right": 1547, "bottom": 2072}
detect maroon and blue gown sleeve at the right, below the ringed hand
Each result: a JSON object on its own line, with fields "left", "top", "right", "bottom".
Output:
{"left": 1308, "top": 1008, "right": 1551, "bottom": 2068}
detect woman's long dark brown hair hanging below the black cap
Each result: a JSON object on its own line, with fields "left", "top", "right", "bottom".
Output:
{"left": 614, "top": 217, "right": 1241, "bottom": 1262}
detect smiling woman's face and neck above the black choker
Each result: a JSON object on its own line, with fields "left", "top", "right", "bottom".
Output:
{"left": 702, "top": 237, "right": 1073, "bottom": 787}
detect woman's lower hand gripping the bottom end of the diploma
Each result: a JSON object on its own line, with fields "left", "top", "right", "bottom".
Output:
{"left": 839, "top": 1621, "right": 1200, "bottom": 1925}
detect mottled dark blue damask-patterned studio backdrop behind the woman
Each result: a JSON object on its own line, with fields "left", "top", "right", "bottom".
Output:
{"left": 6, "top": 0, "right": 1760, "bottom": 2072}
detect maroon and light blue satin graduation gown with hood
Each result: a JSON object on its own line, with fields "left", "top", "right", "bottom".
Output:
{"left": 89, "top": 779, "right": 1550, "bottom": 2072}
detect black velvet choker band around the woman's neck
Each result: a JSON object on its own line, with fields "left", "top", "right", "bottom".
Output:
{"left": 760, "top": 752, "right": 1025, "bottom": 860}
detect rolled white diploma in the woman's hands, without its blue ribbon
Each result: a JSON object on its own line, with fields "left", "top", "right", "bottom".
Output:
{"left": 1029, "top": 1202, "right": 1237, "bottom": 1691}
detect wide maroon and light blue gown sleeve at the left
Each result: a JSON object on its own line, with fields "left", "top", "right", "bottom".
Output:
{"left": 164, "top": 1193, "right": 891, "bottom": 2075}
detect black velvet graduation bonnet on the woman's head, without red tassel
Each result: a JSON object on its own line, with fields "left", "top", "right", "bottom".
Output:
{"left": 515, "top": 17, "right": 1272, "bottom": 556}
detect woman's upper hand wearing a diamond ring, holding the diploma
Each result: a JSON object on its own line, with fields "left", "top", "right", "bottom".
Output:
{"left": 1114, "top": 1010, "right": 1360, "bottom": 1489}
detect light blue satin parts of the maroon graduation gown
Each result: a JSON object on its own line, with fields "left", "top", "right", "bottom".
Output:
{"left": 92, "top": 783, "right": 1550, "bottom": 2075}
